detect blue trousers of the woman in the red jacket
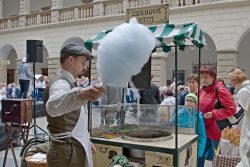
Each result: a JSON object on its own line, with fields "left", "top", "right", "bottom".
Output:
{"left": 198, "top": 138, "right": 220, "bottom": 167}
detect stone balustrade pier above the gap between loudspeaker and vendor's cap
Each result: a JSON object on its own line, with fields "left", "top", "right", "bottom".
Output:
{"left": 51, "top": 0, "right": 63, "bottom": 23}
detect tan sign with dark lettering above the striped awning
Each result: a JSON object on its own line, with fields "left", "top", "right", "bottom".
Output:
{"left": 127, "top": 4, "right": 169, "bottom": 25}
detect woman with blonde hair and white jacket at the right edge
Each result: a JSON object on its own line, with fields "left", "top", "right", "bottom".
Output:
{"left": 228, "top": 69, "right": 250, "bottom": 167}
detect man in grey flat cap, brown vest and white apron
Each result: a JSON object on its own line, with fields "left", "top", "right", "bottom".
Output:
{"left": 44, "top": 44, "right": 105, "bottom": 167}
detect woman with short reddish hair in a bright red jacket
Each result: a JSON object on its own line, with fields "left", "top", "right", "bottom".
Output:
{"left": 200, "top": 66, "right": 236, "bottom": 166}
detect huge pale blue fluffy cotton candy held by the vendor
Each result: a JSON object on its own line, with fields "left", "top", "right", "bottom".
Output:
{"left": 96, "top": 18, "right": 156, "bottom": 86}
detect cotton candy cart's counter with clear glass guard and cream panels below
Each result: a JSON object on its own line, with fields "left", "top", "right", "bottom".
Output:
{"left": 90, "top": 104, "right": 197, "bottom": 167}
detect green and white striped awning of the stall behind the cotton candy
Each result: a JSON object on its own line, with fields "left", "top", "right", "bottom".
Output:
{"left": 85, "top": 23, "right": 206, "bottom": 51}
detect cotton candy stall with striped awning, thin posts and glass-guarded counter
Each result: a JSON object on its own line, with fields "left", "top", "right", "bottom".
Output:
{"left": 85, "top": 23, "right": 206, "bottom": 167}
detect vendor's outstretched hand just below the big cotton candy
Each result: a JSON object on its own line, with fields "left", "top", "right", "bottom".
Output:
{"left": 79, "top": 86, "right": 106, "bottom": 101}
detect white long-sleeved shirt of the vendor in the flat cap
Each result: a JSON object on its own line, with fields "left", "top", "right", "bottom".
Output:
{"left": 46, "top": 69, "right": 87, "bottom": 117}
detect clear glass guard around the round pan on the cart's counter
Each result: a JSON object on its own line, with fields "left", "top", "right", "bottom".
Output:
{"left": 91, "top": 104, "right": 174, "bottom": 139}
